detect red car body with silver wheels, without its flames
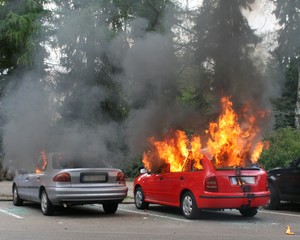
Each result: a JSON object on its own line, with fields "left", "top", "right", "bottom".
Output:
{"left": 133, "top": 156, "right": 270, "bottom": 219}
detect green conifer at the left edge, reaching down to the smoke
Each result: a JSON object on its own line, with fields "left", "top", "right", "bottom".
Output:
{"left": 0, "top": 0, "right": 49, "bottom": 154}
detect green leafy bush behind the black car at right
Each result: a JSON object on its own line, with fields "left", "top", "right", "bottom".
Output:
{"left": 259, "top": 127, "right": 300, "bottom": 170}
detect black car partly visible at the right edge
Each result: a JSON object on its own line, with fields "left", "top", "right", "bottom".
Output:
{"left": 265, "top": 158, "right": 300, "bottom": 210}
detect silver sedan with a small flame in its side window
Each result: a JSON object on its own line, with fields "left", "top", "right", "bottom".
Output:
{"left": 12, "top": 153, "right": 128, "bottom": 215}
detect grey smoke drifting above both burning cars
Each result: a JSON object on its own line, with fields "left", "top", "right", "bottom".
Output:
{"left": 3, "top": 1, "right": 275, "bottom": 172}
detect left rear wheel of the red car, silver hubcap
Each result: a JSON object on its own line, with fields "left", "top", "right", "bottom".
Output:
{"left": 180, "top": 192, "right": 198, "bottom": 219}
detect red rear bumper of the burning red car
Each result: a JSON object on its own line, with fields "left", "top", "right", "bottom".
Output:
{"left": 196, "top": 191, "right": 270, "bottom": 209}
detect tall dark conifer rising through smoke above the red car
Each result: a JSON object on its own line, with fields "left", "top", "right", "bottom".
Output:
{"left": 183, "top": 0, "right": 271, "bottom": 120}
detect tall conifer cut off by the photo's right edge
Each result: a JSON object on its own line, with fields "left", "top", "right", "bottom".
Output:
{"left": 274, "top": 0, "right": 300, "bottom": 128}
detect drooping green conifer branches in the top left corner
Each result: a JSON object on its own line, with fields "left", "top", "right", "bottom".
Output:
{"left": 0, "top": 0, "right": 46, "bottom": 72}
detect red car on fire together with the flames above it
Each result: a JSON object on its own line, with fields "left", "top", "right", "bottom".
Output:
{"left": 133, "top": 98, "right": 270, "bottom": 218}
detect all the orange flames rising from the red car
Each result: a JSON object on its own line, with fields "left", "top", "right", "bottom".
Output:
{"left": 142, "top": 97, "right": 268, "bottom": 172}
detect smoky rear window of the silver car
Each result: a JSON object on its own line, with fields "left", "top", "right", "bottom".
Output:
{"left": 52, "top": 153, "right": 108, "bottom": 169}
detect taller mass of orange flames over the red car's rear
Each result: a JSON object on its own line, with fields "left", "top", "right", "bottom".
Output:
{"left": 207, "top": 97, "right": 267, "bottom": 166}
